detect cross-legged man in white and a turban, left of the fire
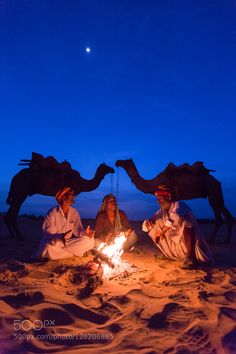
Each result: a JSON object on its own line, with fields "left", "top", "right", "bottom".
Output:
{"left": 37, "top": 187, "right": 94, "bottom": 260}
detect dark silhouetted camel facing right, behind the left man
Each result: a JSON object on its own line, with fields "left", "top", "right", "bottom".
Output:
{"left": 4, "top": 153, "right": 115, "bottom": 240}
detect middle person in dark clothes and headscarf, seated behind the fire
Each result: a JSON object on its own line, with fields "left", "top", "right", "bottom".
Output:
{"left": 95, "top": 194, "right": 137, "bottom": 251}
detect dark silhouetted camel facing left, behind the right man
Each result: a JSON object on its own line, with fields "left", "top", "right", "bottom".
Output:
{"left": 116, "top": 159, "right": 234, "bottom": 243}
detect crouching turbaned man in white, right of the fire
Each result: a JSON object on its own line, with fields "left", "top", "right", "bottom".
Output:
{"left": 143, "top": 185, "right": 212, "bottom": 268}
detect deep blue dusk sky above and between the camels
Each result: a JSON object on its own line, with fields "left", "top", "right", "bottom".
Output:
{"left": 0, "top": 0, "right": 236, "bottom": 219}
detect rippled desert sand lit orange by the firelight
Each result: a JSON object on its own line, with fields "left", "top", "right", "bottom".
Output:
{"left": 0, "top": 216, "right": 236, "bottom": 354}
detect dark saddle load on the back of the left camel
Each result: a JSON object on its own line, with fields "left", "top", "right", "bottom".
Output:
{"left": 19, "top": 152, "right": 71, "bottom": 170}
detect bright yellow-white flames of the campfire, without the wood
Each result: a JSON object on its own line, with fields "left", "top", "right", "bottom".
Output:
{"left": 98, "top": 232, "right": 130, "bottom": 279}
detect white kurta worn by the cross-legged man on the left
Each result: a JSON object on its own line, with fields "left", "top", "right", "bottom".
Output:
{"left": 37, "top": 206, "right": 94, "bottom": 260}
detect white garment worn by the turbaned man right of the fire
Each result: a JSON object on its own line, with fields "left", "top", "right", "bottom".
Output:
{"left": 142, "top": 201, "right": 212, "bottom": 262}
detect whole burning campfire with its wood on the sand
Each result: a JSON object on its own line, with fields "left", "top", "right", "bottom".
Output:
{"left": 97, "top": 232, "right": 132, "bottom": 279}
